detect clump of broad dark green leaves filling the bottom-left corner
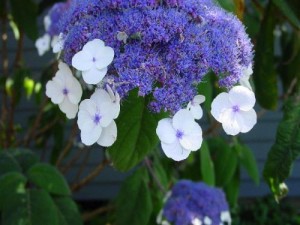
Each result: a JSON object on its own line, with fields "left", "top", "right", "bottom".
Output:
{"left": 0, "top": 149, "right": 82, "bottom": 225}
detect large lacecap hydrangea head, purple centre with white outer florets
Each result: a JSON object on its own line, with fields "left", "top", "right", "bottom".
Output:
{"left": 41, "top": 0, "right": 256, "bottom": 158}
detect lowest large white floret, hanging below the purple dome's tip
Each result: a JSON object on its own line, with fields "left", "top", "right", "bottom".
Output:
{"left": 156, "top": 109, "right": 202, "bottom": 161}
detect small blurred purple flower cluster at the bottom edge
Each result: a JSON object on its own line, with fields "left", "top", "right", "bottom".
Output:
{"left": 163, "top": 180, "right": 229, "bottom": 225}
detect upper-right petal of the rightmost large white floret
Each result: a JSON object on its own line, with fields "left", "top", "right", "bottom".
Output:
{"left": 228, "top": 86, "right": 255, "bottom": 111}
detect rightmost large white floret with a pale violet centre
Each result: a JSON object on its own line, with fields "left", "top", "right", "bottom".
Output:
{"left": 211, "top": 86, "right": 257, "bottom": 135}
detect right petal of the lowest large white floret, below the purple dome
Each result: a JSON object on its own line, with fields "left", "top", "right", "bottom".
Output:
{"left": 179, "top": 122, "right": 202, "bottom": 151}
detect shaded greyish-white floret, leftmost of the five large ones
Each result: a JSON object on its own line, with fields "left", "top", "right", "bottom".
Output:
{"left": 46, "top": 62, "right": 82, "bottom": 119}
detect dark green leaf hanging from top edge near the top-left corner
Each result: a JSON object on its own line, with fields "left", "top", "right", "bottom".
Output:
{"left": 9, "top": 0, "right": 38, "bottom": 40}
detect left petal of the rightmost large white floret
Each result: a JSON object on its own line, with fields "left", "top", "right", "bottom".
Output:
{"left": 211, "top": 92, "right": 232, "bottom": 123}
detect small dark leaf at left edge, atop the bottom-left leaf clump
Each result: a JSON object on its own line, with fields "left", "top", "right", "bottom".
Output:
{"left": 0, "top": 150, "right": 22, "bottom": 177}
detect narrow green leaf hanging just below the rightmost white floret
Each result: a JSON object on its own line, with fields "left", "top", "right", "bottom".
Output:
{"left": 234, "top": 143, "right": 259, "bottom": 185}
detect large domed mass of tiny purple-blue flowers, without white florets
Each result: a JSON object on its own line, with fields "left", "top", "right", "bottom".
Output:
{"left": 57, "top": 0, "right": 253, "bottom": 113}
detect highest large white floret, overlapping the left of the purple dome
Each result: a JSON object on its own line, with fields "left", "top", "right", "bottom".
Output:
{"left": 72, "top": 39, "right": 114, "bottom": 84}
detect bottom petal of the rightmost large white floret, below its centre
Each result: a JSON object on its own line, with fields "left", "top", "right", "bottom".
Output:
{"left": 220, "top": 109, "right": 241, "bottom": 135}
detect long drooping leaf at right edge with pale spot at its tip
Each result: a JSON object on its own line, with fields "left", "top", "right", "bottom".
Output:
{"left": 263, "top": 91, "right": 300, "bottom": 199}
